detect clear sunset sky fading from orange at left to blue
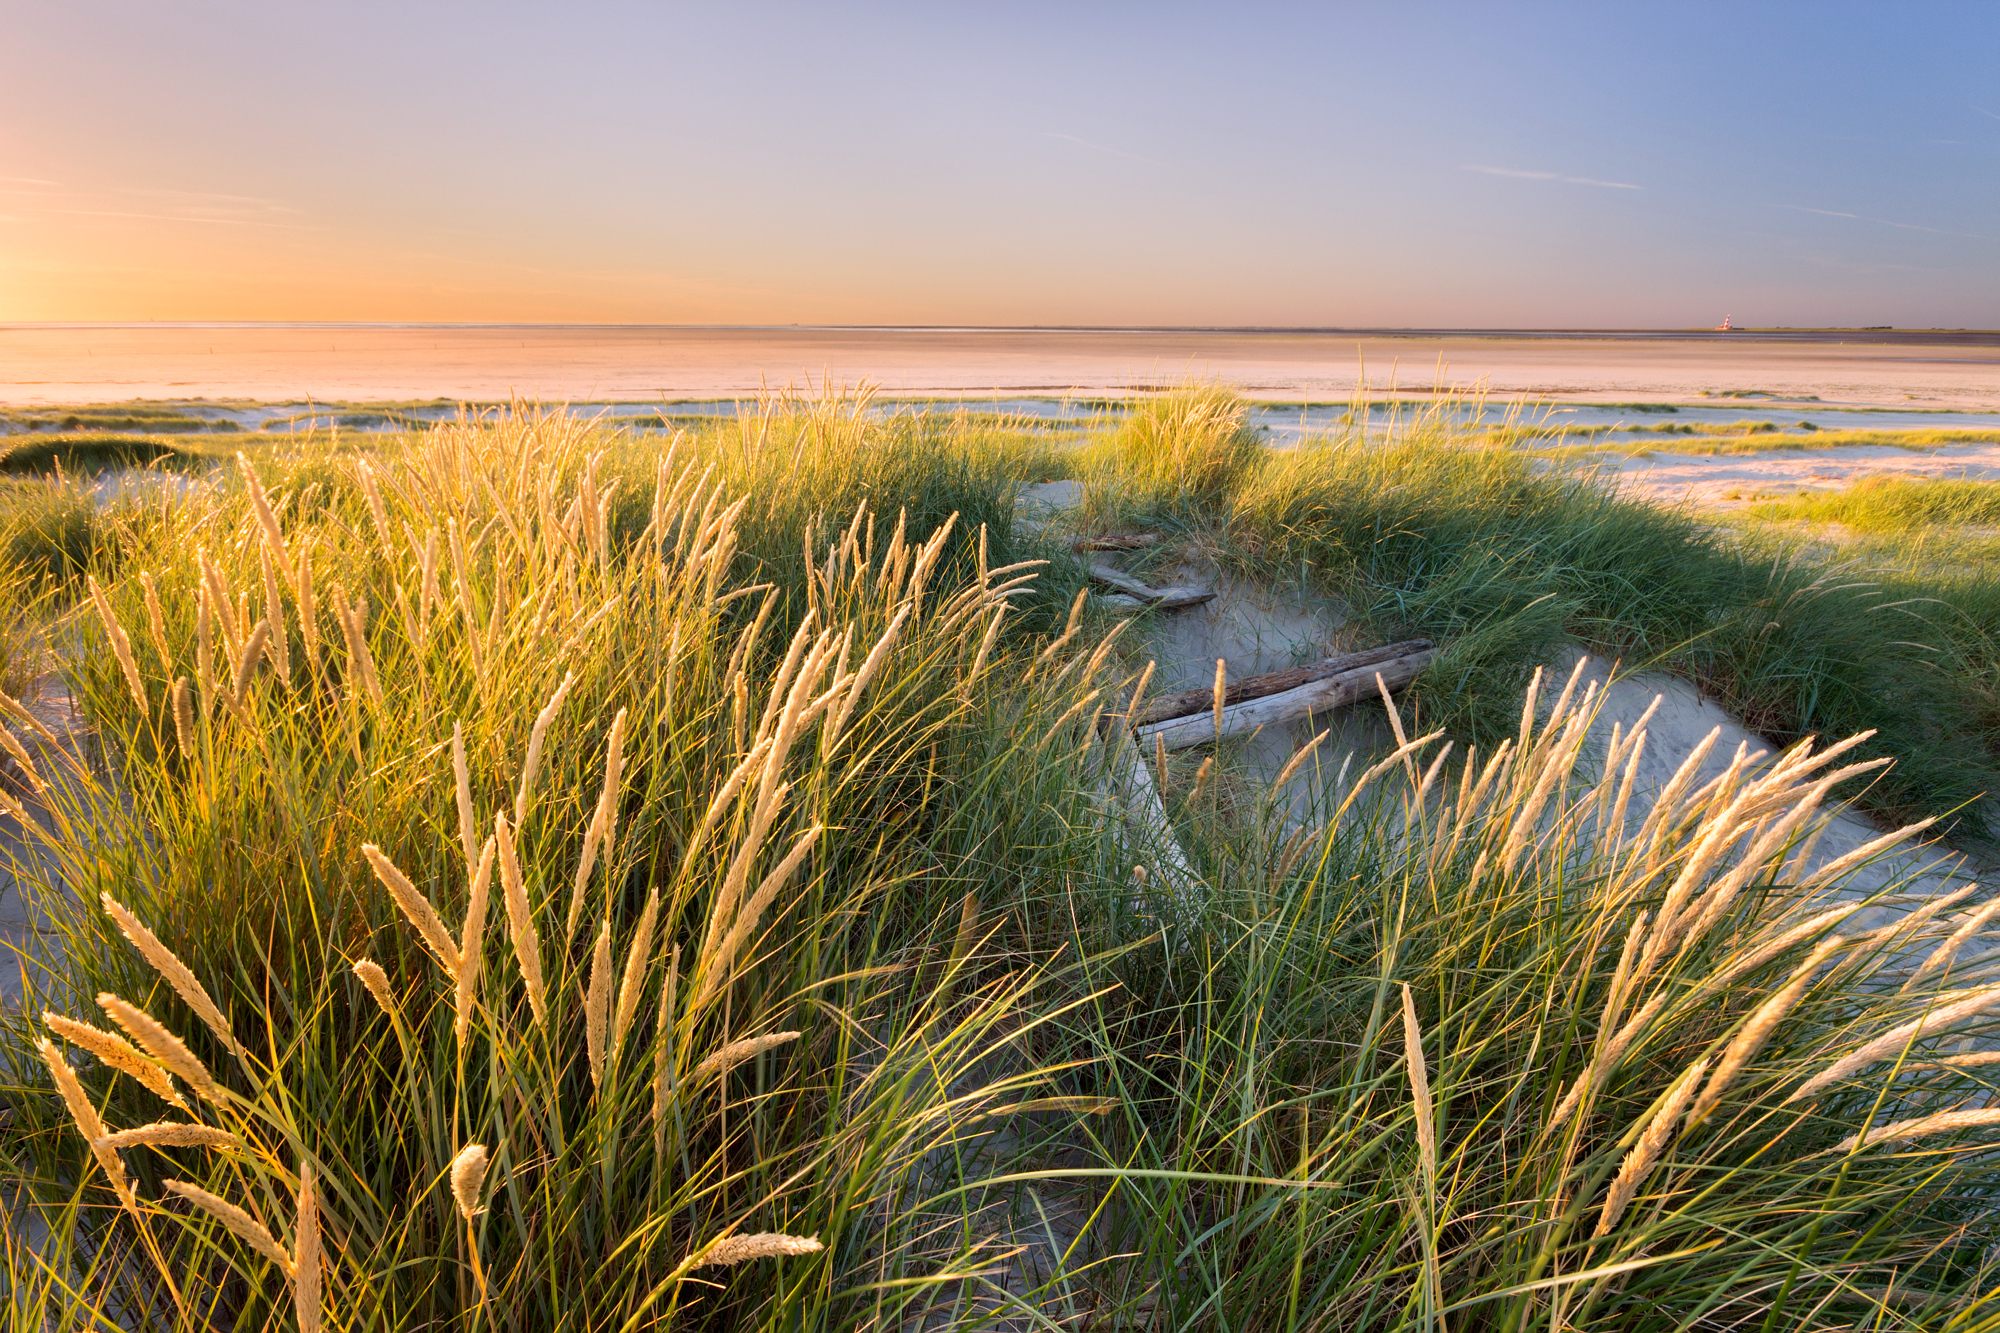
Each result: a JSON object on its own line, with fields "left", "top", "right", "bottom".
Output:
{"left": 0, "top": 0, "right": 2000, "bottom": 328}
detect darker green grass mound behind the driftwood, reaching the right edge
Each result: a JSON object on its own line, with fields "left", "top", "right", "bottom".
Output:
{"left": 1076, "top": 388, "right": 2000, "bottom": 835}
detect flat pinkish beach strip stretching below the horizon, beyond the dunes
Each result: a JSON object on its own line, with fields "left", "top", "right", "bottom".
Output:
{"left": 0, "top": 324, "right": 2000, "bottom": 410}
